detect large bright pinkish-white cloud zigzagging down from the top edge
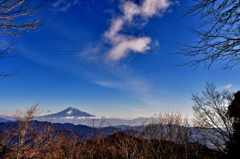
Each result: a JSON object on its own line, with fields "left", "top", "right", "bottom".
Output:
{"left": 104, "top": 0, "right": 171, "bottom": 61}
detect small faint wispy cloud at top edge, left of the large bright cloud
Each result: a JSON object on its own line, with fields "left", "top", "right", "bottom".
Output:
{"left": 52, "top": 0, "right": 79, "bottom": 12}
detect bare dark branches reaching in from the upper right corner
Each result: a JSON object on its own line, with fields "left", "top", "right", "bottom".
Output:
{"left": 175, "top": 0, "right": 240, "bottom": 69}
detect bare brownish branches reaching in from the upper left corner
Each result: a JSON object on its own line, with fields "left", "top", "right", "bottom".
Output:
{"left": 0, "top": 0, "right": 47, "bottom": 77}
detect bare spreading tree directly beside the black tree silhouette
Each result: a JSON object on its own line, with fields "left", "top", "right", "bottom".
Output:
{"left": 192, "top": 82, "right": 233, "bottom": 152}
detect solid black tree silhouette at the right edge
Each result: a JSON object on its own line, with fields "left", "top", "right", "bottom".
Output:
{"left": 226, "top": 91, "right": 240, "bottom": 158}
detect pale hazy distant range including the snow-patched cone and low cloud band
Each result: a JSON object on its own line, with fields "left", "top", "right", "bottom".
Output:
{"left": 0, "top": 107, "right": 152, "bottom": 127}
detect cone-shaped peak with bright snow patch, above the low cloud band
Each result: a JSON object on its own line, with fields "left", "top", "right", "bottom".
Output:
{"left": 38, "top": 107, "right": 95, "bottom": 118}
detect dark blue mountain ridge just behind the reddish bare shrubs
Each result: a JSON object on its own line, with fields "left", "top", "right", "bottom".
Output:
{"left": 0, "top": 120, "right": 217, "bottom": 153}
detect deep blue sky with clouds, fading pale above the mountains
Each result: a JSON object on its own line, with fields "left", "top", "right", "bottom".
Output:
{"left": 0, "top": 0, "right": 239, "bottom": 118}
